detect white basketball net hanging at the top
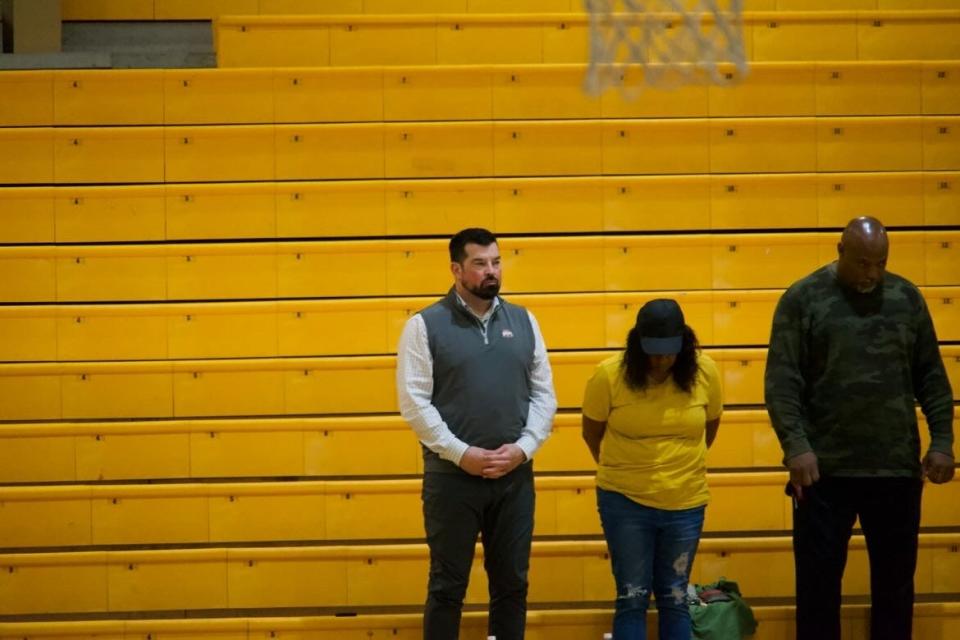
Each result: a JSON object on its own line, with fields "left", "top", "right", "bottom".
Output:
{"left": 584, "top": 0, "right": 748, "bottom": 95}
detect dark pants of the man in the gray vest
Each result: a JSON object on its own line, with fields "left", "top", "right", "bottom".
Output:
{"left": 423, "top": 464, "right": 534, "bottom": 640}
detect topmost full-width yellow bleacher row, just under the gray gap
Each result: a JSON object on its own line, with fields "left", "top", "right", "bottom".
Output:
{"left": 0, "top": 60, "right": 960, "bottom": 127}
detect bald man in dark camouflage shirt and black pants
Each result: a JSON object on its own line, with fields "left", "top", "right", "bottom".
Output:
{"left": 765, "top": 217, "right": 954, "bottom": 640}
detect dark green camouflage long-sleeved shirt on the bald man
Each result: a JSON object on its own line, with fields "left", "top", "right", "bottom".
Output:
{"left": 765, "top": 264, "right": 953, "bottom": 477}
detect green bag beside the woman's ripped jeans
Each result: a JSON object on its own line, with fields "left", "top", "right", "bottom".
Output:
{"left": 690, "top": 578, "right": 757, "bottom": 640}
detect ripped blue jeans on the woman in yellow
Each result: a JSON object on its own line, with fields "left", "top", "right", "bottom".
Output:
{"left": 597, "top": 488, "right": 705, "bottom": 640}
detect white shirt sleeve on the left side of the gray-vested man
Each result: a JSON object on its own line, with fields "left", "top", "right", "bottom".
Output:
{"left": 397, "top": 313, "right": 470, "bottom": 466}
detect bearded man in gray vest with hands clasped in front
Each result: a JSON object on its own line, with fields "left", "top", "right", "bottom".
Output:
{"left": 397, "top": 229, "right": 557, "bottom": 640}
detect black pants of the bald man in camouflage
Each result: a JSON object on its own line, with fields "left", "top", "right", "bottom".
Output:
{"left": 793, "top": 477, "right": 923, "bottom": 640}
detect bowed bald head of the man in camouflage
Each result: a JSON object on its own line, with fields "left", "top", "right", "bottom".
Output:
{"left": 837, "top": 216, "right": 890, "bottom": 293}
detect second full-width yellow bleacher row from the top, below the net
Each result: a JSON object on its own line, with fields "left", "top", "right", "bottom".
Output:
{"left": 0, "top": 116, "right": 960, "bottom": 184}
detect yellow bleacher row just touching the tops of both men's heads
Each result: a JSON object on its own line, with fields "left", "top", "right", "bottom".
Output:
{"left": 0, "top": 171, "right": 960, "bottom": 244}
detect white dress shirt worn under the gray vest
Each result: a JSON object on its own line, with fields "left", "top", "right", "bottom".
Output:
{"left": 397, "top": 296, "right": 557, "bottom": 466}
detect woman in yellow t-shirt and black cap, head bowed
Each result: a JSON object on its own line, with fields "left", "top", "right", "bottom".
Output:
{"left": 583, "top": 298, "right": 723, "bottom": 640}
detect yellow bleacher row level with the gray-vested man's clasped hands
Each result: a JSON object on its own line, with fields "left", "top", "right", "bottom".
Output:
{"left": 0, "top": 409, "right": 960, "bottom": 482}
